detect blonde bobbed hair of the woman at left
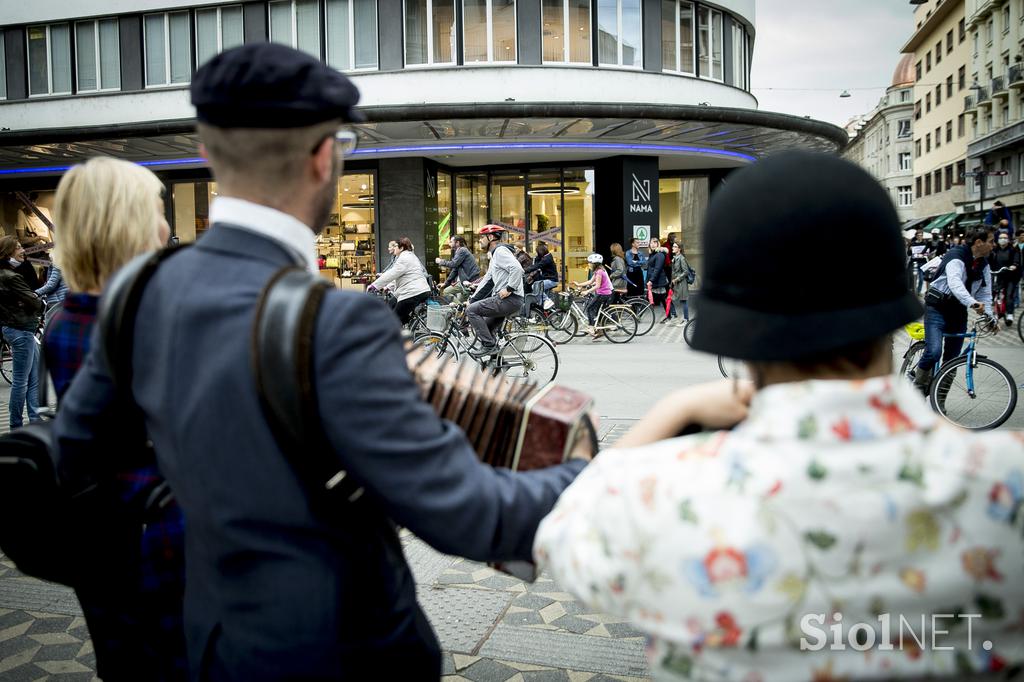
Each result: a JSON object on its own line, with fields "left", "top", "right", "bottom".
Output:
{"left": 53, "top": 157, "right": 164, "bottom": 291}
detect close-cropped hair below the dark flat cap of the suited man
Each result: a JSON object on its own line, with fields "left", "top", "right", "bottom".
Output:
{"left": 197, "top": 120, "right": 342, "bottom": 197}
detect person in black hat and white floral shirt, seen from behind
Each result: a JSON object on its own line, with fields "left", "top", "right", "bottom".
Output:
{"left": 535, "top": 153, "right": 1024, "bottom": 682}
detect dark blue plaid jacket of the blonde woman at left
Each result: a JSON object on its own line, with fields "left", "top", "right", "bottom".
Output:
{"left": 43, "top": 293, "right": 187, "bottom": 680}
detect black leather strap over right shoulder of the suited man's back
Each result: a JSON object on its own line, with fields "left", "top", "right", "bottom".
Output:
{"left": 251, "top": 266, "right": 364, "bottom": 504}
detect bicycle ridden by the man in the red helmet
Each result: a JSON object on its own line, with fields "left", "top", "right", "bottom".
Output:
{"left": 415, "top": 304, "right": 558, "bottom": 386}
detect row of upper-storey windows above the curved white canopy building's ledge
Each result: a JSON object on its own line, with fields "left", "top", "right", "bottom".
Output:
{"left": 0, "top": 0, "right": 752, "bottom": 98}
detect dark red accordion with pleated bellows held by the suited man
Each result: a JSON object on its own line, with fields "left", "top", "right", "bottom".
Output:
{"left": 406, "top": 343, "right": 593, "bottom": 471}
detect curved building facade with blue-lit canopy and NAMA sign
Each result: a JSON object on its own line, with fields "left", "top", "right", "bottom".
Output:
{"left": 0, "top": 0, "right": 846, "bottom": 287}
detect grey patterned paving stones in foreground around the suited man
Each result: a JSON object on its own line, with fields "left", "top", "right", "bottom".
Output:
{"left": 0, "top": 413, "right": 649, "bottom": 682}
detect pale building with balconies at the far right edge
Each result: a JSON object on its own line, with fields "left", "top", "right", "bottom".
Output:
{"left": 964, "top": 0, "right": 1024, "bottom": 224}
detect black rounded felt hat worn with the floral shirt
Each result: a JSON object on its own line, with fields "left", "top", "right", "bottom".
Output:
{"left": 693, "top": 152, "right": 924, "bottom": 361}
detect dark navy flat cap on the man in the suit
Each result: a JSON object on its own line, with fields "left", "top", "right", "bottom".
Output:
{"left": 191, "top": 43, "right": 362, "bottom": 128}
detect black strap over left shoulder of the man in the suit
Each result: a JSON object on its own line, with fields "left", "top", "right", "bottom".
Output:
{"left": 96, "top": 244, "right": 189, "bottom": 395}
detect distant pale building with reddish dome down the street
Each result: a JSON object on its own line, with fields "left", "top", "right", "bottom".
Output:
{"left": 843, "top": 54, "right": 915, "bottom": 221}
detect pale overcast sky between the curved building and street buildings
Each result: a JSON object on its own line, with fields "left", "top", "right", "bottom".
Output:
{"left": 751, "top": 0, "right": 914, "bottom": 126}
